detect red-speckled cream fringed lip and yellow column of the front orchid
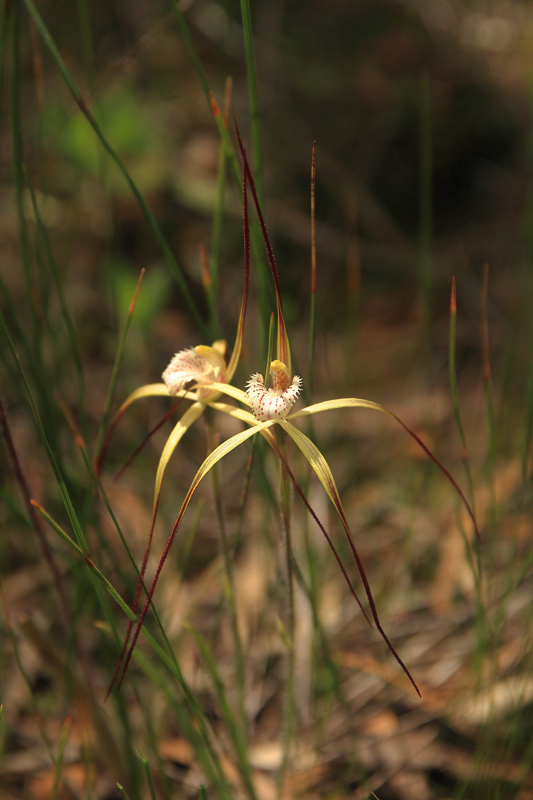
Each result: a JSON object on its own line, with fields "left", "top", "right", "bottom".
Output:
{"left": 246, "top": 359, "right": 302, "bottom": 420}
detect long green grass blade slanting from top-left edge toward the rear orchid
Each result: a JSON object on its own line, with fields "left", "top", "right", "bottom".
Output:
{"left": 18, "top": 0, "right": 208, "bottom": 336}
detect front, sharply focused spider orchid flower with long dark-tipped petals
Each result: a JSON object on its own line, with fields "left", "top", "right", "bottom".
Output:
{"left": 112, "top": 130, "right": 479, "bottom": 694}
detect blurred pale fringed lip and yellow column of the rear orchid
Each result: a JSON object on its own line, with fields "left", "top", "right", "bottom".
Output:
{"left": 162, "top": 340, "right": 226, "bottom": 400}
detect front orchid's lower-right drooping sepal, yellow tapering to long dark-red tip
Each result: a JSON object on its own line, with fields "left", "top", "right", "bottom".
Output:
{"left": 279, "top": 420, "right": 420, "bottom": 695}
